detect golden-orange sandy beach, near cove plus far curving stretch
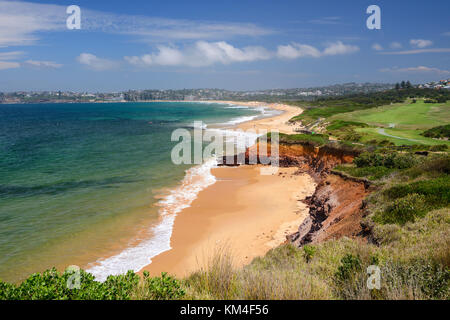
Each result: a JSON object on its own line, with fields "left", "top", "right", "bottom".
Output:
{"left": 141, "top": 101, "right": 315, "bottom": 277}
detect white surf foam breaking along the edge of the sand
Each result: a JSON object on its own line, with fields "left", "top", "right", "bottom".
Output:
{"left": 86, "top": 102, "right": 277, "bottom": 281}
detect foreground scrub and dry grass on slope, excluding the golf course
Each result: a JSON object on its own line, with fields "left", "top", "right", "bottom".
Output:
{"left": 0, "top": 148, "right": 450, "bottom": 300}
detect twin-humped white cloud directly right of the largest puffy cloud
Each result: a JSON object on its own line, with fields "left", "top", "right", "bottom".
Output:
{"left": 277, "top": 41, "right": 359, "bottom": 59}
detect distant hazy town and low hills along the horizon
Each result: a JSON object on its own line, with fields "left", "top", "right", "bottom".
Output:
{"left": 0, "top": 79, "right": 450, "bottom": 104}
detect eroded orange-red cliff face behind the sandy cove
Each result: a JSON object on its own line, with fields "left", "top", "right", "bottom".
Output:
{"left": 223, "top": 143, "right": 371, "bottom": 246}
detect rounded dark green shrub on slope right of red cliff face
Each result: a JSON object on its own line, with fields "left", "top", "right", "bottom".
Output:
{"left": 379, "top": 193, "right": 427, "bottom": 225}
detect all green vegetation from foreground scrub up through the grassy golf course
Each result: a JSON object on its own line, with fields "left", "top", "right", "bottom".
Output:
{"left": 0, "top": 82, "right": 450, "bottom": 300}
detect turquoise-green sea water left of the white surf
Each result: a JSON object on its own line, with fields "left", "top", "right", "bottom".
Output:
{"left": 0, "top": 102, "right": 259, "bottom": 281}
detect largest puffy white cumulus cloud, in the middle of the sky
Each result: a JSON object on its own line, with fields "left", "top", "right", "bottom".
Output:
{"left": 124, "top": 41, "right": 272, "bottom": 67}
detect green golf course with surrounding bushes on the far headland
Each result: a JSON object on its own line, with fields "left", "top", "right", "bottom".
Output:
{"left": 291, "top": 87, "right": 450, "bottom": 146}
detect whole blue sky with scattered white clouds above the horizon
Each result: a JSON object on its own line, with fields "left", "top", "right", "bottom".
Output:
{"left": 0, "top": 0, "right": 450, "bottom": 92}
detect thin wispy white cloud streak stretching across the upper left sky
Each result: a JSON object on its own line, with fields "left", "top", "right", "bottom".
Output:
{"left": 0, "top": 0, "right": 275, "bottom": 46}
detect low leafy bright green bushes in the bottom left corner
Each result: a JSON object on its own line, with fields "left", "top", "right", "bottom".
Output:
{"left": 0, "top": 269, "right": 185, "bottom": 300}
